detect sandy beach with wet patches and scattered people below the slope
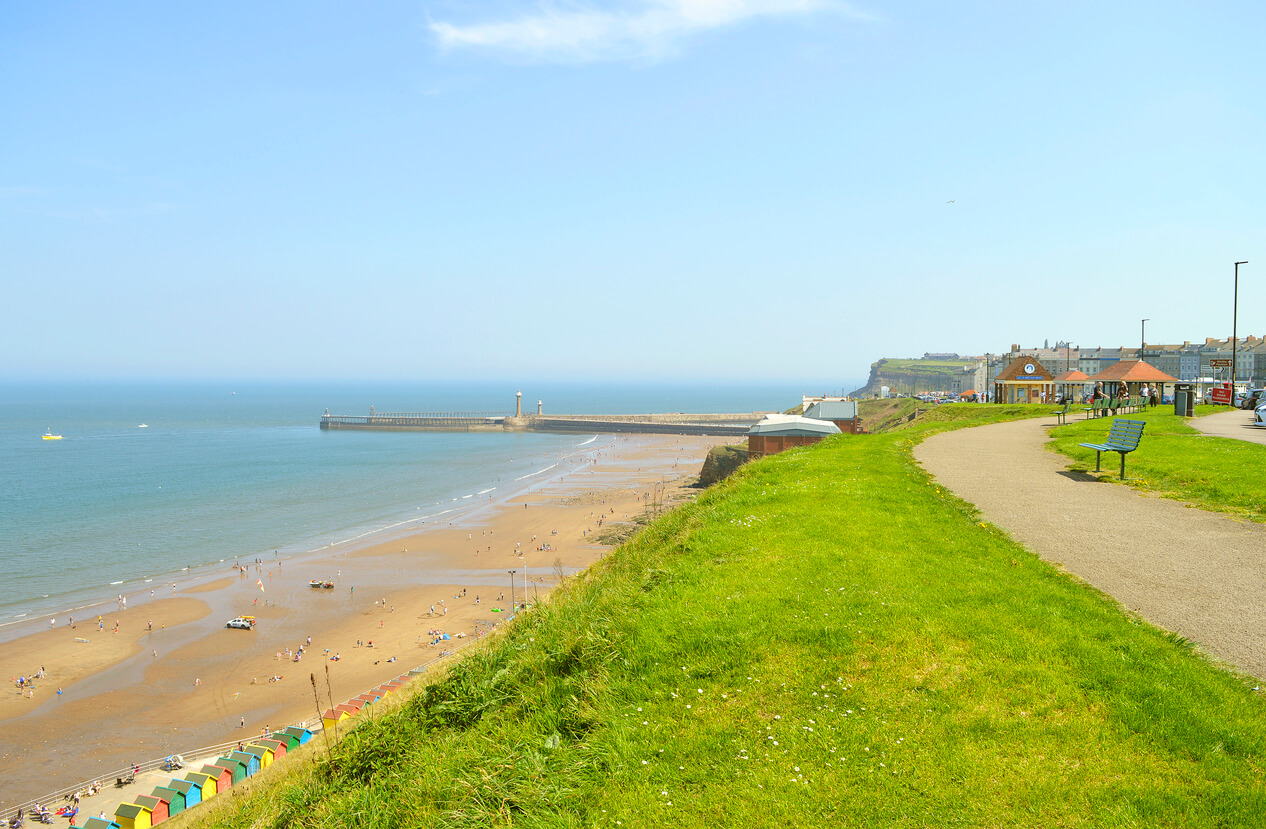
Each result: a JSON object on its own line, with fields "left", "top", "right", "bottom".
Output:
{"left": 0, "top": 435, "right": 724, "bottom": 809}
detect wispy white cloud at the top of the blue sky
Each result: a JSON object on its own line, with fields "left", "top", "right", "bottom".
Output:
{"left": 430, "top": 0, "right": 868, "bottom": 62}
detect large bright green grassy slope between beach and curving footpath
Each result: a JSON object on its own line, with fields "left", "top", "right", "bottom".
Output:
{"left": 195, "top": 406, "right": 1266, "bottom": 828}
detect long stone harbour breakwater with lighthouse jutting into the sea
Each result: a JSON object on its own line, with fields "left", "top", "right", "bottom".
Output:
{"left": 320, "top": 413, "right": 763, "bottom": 437}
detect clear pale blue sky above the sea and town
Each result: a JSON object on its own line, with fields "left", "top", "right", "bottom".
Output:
{"left": 0, "top": 0, "right": 1266, "bottom": 390}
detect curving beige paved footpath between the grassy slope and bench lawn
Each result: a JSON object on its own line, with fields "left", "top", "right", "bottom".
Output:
{"left": 914, "top": 413, "right": 1266, "bottom": 677}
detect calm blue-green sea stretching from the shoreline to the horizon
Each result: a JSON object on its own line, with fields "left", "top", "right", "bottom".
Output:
{"left": 0, "top": 381, "right": 801, "bottom": 626}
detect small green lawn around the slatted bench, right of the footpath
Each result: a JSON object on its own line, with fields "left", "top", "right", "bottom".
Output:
{"left": 1051, "top": 406, "right": 1266, "bottom": 521}
